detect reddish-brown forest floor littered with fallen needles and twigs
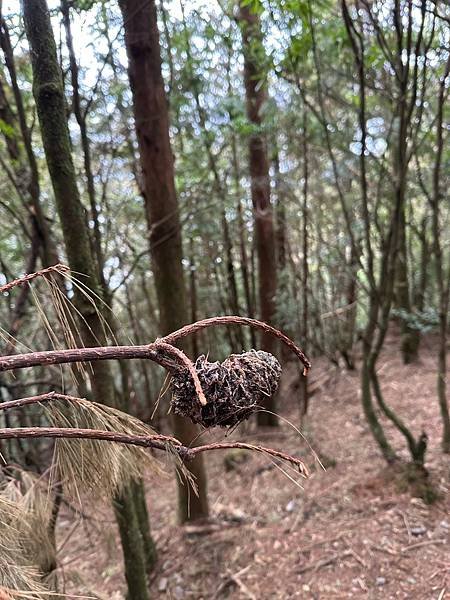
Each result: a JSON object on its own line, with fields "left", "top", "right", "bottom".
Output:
{"left": 58, "top": 338, "right": 450, "bottom": 600}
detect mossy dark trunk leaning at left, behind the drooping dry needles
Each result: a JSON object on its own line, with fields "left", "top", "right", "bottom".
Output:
{"left": 23, "top": 0, "right": 148, "bottom": 600}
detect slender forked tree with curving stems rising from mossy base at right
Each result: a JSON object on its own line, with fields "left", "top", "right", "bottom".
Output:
{"left": 341, "top": 0, "right": 426, "bottom": 463}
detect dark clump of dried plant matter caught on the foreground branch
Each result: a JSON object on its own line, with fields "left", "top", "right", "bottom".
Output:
{"left": 171, "top": 350, "right": 281, "bottom": 427}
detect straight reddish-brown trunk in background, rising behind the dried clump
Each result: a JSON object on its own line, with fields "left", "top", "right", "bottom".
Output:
{"left": 239, "top": 1, "right": 278, "bottom": 426}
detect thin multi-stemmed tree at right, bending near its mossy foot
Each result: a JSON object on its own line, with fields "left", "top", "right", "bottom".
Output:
{"left": 341, "top": 0, "right": 427, "bottom": 466}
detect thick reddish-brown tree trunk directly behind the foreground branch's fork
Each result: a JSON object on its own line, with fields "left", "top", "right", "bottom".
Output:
{"left": 120, "top": 0, "right": 208, "bottom": 522}
